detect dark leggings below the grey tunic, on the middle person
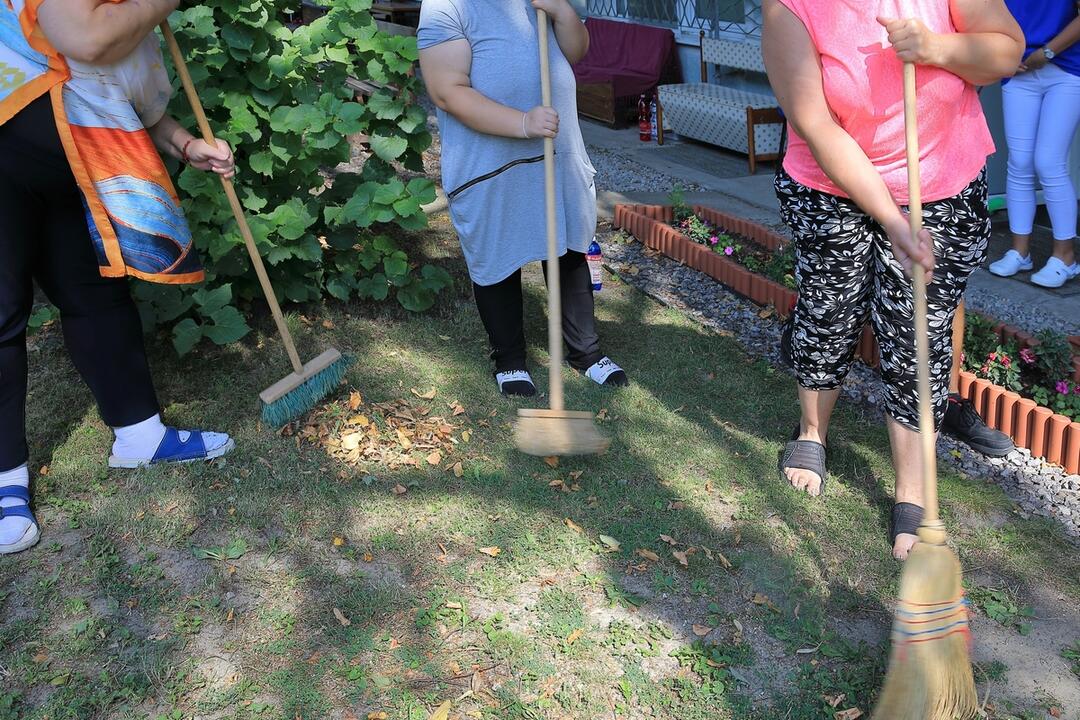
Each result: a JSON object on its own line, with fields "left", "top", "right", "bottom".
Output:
{"left": 473, "top": 250, "right": 603, "bottom": 372}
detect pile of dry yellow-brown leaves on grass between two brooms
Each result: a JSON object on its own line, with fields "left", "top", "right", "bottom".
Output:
{"left": 283, "top": 390, "right": 472, "bottom": 476}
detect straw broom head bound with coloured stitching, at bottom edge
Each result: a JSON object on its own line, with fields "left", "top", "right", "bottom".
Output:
{"left": 873, "top": 521, "right": 978, "bottom": 720}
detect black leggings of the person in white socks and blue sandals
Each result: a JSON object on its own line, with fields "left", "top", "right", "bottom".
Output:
{"left": 0, "top": 96, "right": 159, "bottom": 472}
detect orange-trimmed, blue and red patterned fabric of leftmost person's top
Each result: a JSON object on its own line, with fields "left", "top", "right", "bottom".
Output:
{"left": 0, "top": 0, "right": 203, "bottom": 284}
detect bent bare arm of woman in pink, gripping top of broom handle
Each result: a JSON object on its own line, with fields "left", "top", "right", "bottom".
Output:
{"left": 878, "top": 0, "right": 1025, "bottom": 85}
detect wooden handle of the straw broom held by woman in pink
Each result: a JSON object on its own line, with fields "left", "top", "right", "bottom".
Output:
{"left": 904, "top": 63, "right": 939, "bottom": 525}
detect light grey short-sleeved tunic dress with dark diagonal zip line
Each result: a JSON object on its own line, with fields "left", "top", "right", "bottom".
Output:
{"left": 417, "top": 0, "right": 596, "bottom": 285}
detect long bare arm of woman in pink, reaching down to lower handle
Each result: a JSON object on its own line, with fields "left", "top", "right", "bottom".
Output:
{"left": 761, "top": 0, "right": 933, "bottom": 270}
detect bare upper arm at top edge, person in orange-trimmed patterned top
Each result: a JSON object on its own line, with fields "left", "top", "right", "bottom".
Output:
{"left": 38, "top": 0, "right": 179, "bottom": 65}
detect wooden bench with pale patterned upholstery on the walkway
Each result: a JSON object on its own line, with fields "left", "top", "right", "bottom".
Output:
{"left": 658, "top": 30, "right": 786, "bottom": 175}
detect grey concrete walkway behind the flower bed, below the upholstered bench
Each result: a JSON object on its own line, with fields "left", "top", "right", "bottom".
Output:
{"left": 582, "top": 122, "right": 1080, "bottom": 335}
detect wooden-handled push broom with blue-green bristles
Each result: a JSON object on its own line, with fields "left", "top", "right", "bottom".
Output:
{"left": 161, "top": 23, "right": 348, "bottom": 427}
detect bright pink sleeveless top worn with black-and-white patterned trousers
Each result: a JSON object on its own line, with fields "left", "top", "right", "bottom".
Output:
{"left": 780, "top": 0, "right": 994, "bottom": 205}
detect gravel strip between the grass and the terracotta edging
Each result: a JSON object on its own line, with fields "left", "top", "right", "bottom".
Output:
{"left": 598, "top": 223, "right": 1080, "bottom": 544}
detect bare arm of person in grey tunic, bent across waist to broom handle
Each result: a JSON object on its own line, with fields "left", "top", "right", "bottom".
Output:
{"left": 420, "top": 40, "right": 558, "bottom": 138}
